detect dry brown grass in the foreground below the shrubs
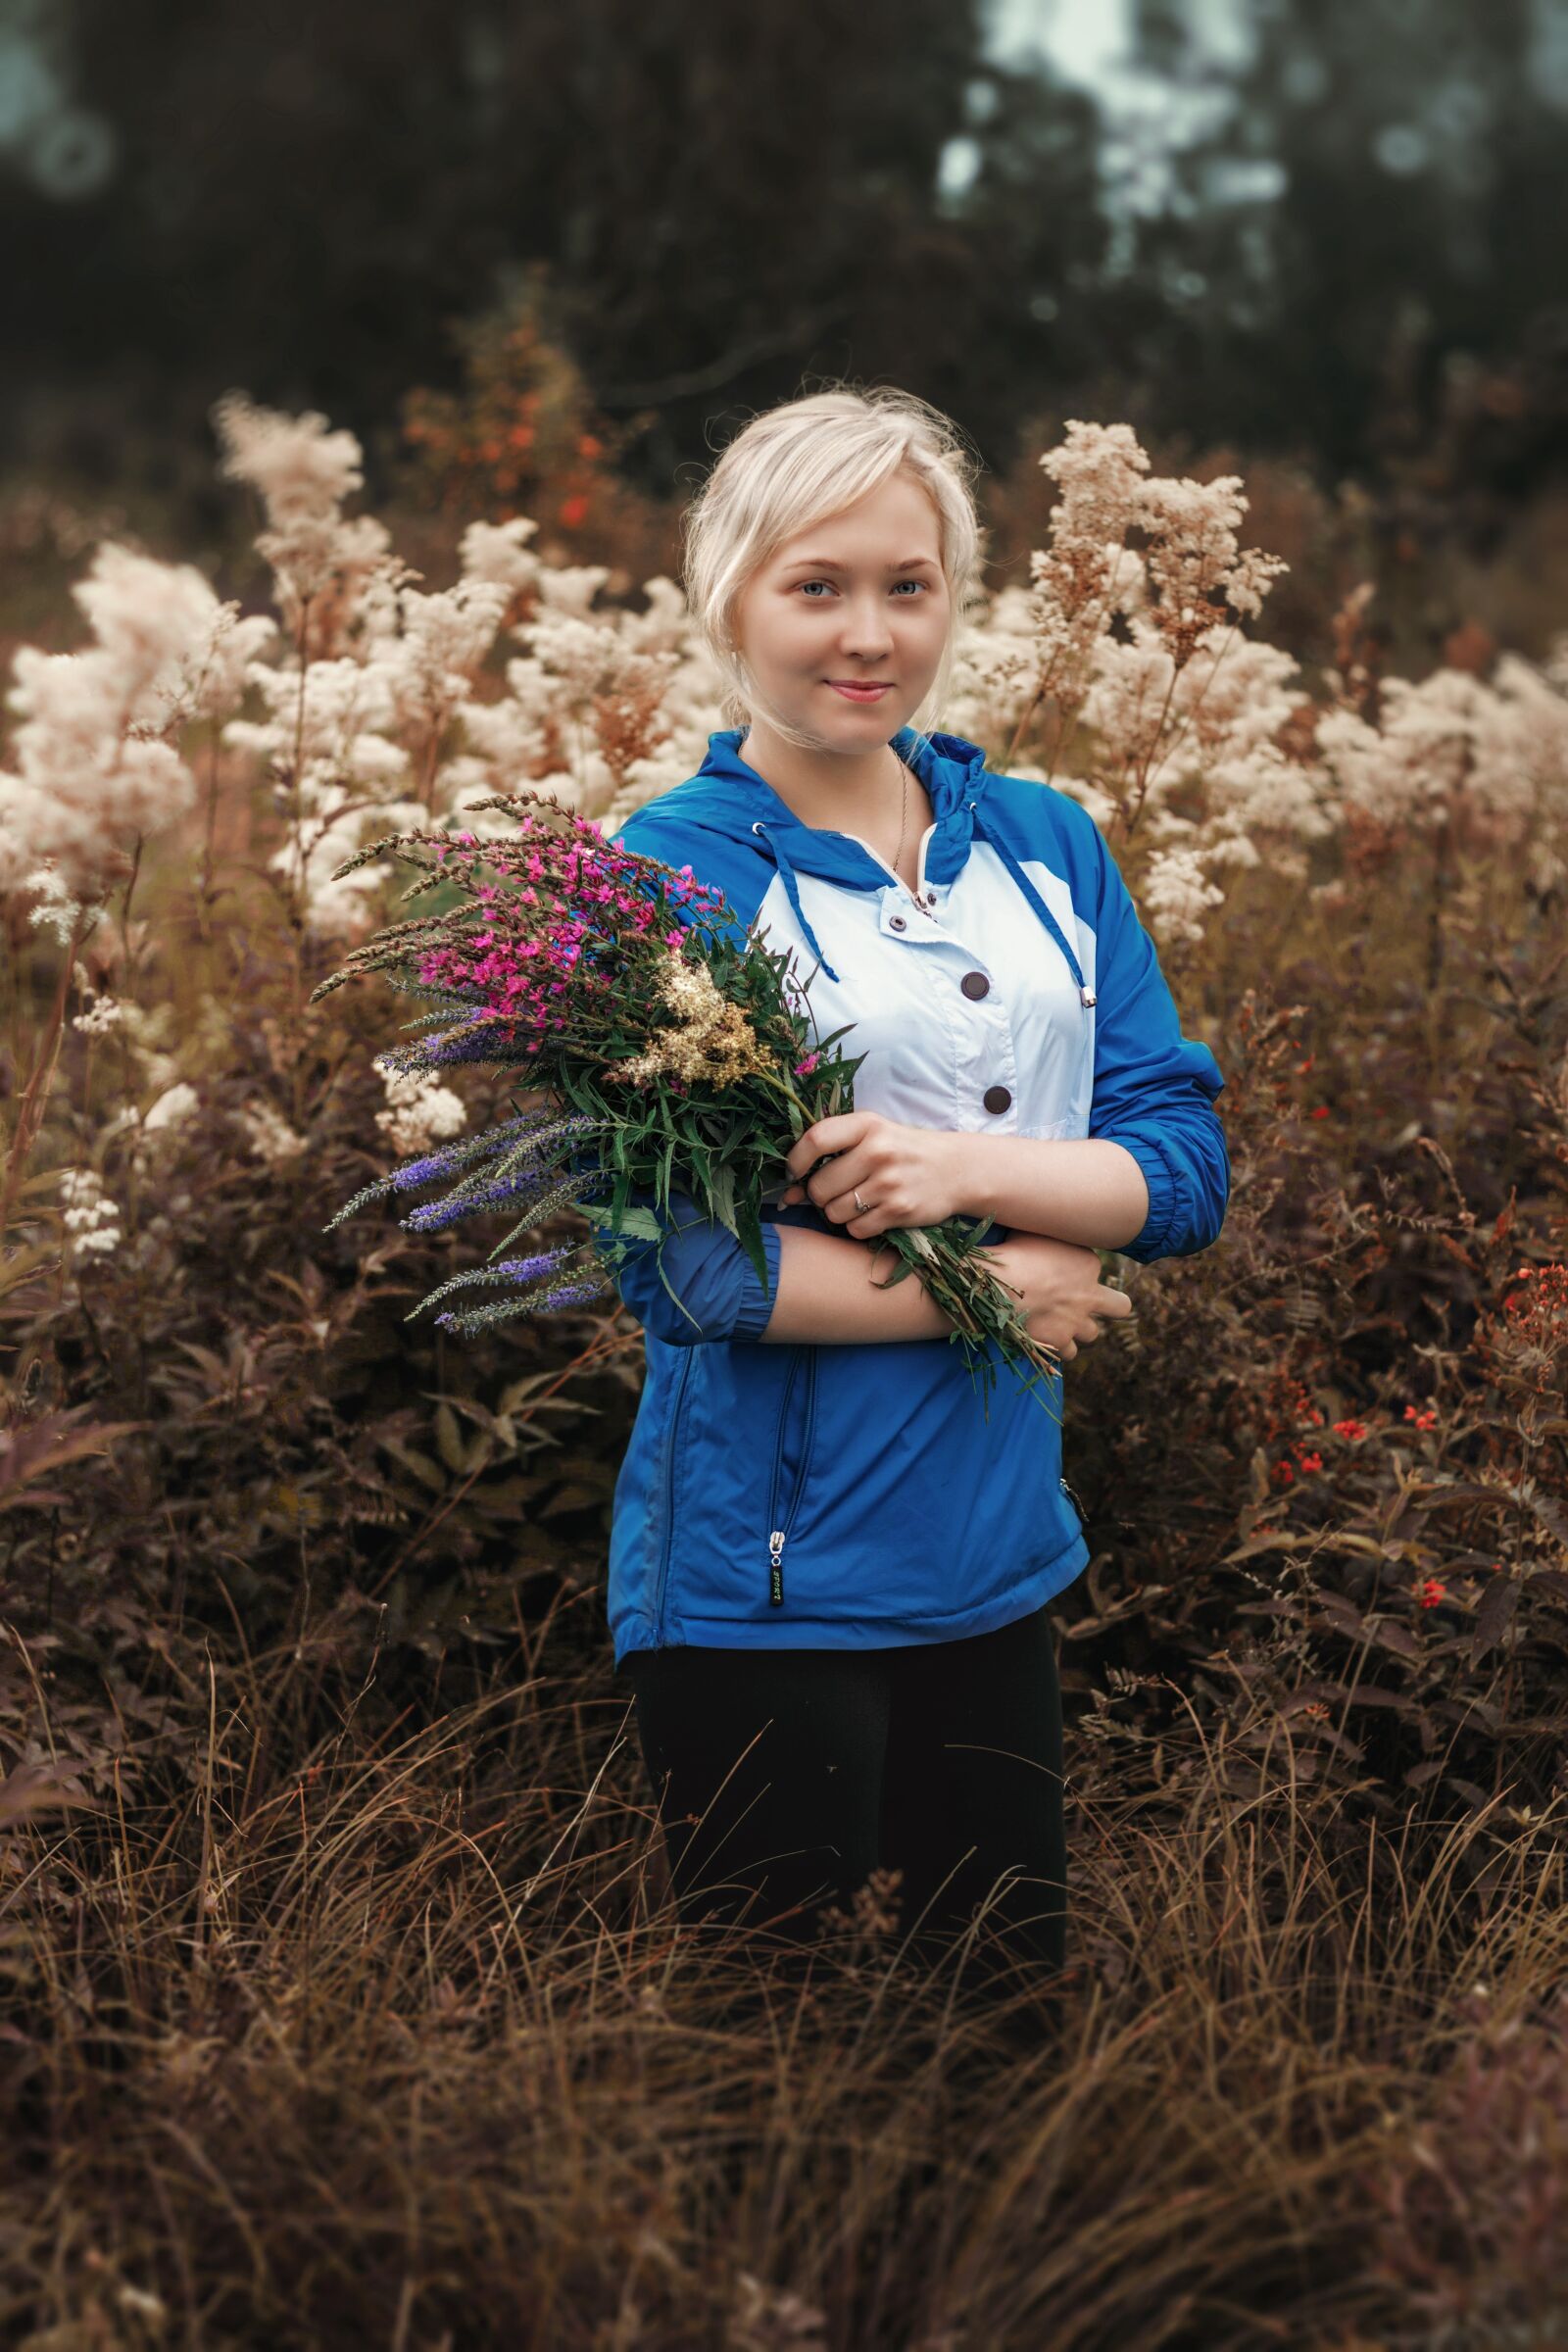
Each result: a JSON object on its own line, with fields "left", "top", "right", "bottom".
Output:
{"left": 0, "top": 1571, "right": 1568, "bottom": 2352}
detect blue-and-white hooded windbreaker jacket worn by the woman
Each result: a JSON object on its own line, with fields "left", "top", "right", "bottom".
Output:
{"left": 595, "top": 727, "right": 1230, "bottom": 1665}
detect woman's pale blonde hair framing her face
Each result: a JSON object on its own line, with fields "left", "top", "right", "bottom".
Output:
{"left": 684, "top": 383, "right": 983, "bottom": 748}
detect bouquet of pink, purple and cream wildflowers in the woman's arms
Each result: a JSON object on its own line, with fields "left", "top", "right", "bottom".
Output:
{"left": 311, "top": 793, "right": 1060, "bottom": 1418}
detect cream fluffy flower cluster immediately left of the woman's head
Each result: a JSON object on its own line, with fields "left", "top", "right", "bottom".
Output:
{"left": 201, "top": 393, "right": 719, "bottom": 939}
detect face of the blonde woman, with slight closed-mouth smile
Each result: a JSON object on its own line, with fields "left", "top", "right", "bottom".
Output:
{"left": 733, "top": 472, "right": 953, "bottom": 753}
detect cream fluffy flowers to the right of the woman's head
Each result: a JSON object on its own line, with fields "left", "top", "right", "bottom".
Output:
{"left": 948, "top": 423, "right": 1568, "bottom": 946}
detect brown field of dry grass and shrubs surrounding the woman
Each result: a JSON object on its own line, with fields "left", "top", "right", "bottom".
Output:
{"left": 0, "top": 432, "right": 1568, "bottom": 2352}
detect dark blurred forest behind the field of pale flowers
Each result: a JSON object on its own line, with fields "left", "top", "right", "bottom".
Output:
{"left": 0, "top": 0, "right": 1568, "bottom": 659}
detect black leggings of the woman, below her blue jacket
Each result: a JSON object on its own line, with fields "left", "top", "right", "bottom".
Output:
{"left": 620, "top": 1606, "right": 1067, "bottom": 1981}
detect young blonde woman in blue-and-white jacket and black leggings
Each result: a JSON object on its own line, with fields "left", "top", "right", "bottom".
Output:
{"left": 587, "top": 388, "right": 1230, "bottom": 2003}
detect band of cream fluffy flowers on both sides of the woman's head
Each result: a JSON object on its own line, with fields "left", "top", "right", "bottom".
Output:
{"left": 0, "top": 393, "right": 1568, "bottom": 968}
